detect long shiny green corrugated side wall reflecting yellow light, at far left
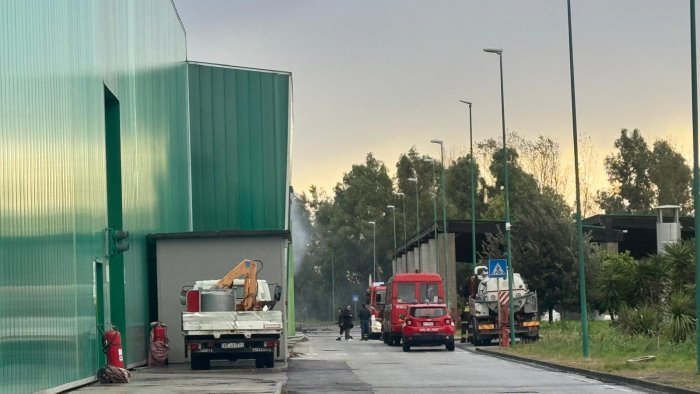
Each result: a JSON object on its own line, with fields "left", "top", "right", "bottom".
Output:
{"left": 0, "top": 0, "right": 190, "bottom": 392}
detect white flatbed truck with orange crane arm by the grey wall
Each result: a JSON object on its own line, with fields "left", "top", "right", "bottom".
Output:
{"left": 181, "top": 260, "right": 283, "bottom": 370}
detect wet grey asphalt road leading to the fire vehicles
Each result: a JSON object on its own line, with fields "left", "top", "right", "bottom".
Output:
{"left": 286, "top": 331, "right": 647, "bottom": 394}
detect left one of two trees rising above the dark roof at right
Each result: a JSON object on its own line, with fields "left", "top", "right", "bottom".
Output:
{"left": 597, "top": 129, "right": 654, "bottom": 213}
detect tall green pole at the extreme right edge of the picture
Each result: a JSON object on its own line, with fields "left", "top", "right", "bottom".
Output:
{"left": 690, "top": 0, "right": 700, "bottom": 373}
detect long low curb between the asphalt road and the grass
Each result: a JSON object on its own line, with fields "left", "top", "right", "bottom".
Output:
{"left": 474, "top": 348, "right": 698, "bottom": 394}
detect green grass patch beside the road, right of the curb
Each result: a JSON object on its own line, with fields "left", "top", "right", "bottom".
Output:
{"left": 491, "top": 321, "right": 700, "bottom": 390}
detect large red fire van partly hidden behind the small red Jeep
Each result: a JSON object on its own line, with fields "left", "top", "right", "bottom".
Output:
{"left": 382, "top": 273, "right": 445, "bottom": 346}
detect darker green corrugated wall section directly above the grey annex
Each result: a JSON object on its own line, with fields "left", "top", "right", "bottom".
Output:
{"left": 189, "top": 63, "right": 291, "bottom": 231}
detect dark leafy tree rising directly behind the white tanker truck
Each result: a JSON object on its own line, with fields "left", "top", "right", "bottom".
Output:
{"left": 481, "top": 148, "right": 577, "bottom": 318}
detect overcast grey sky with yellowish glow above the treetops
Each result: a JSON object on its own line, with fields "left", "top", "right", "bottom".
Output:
{"left": 175, "top": 0, "right": 692, "bottom": 194}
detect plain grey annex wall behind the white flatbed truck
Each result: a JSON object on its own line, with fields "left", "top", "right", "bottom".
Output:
{"left": 156, "top": 236, "right": 287, "bottom": 363}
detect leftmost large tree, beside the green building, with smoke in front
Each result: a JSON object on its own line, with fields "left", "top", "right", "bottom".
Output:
{"left": 294, "top": 153, "right": 395, "bottom": 319}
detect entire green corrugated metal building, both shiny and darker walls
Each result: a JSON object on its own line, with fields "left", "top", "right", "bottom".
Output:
{"left": 0, "top": 0, "right": 291, "bottom": 393}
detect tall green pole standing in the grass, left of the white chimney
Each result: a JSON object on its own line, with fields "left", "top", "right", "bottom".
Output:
{"left": 566, "top": 0, "right": 589, "bottom": 358}
